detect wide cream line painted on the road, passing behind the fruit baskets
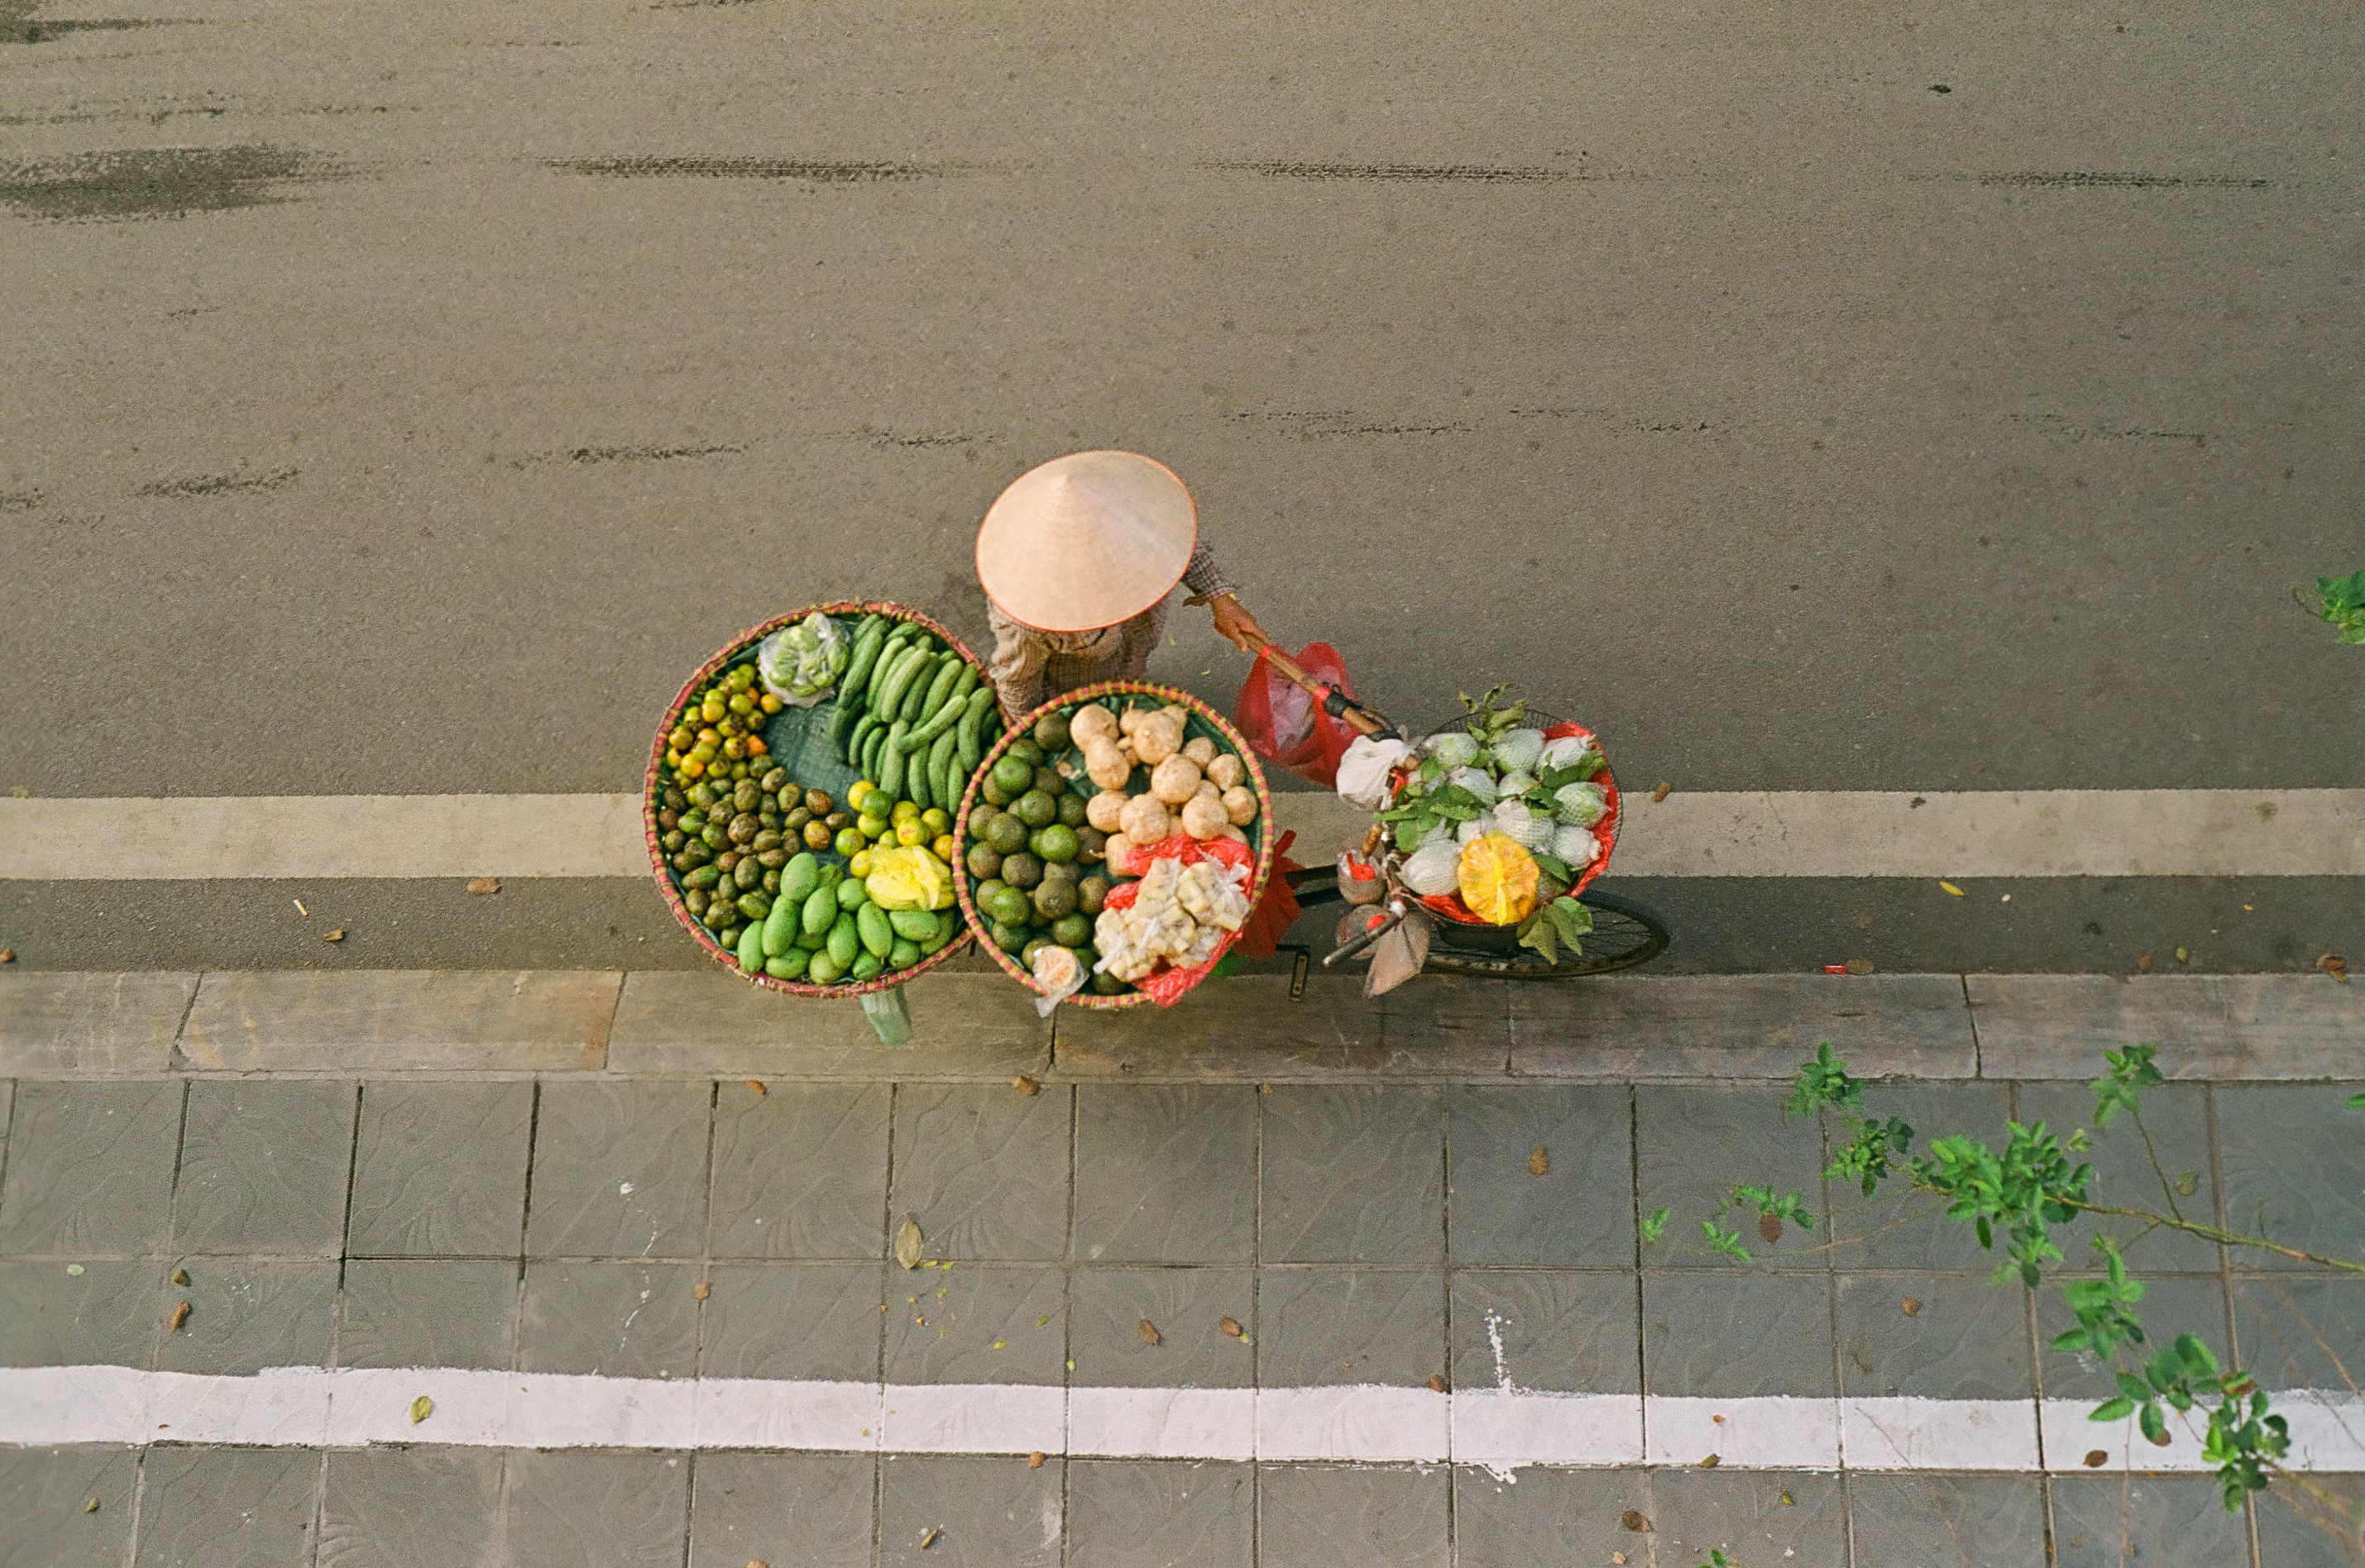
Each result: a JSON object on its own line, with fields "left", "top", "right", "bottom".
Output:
{"left": 0, "top": 790, "right": 2365, "bottom": 882}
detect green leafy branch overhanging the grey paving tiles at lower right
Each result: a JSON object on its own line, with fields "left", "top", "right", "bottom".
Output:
{"left": 1641, "top": 1040, "right": 2365, "bottom": 1535}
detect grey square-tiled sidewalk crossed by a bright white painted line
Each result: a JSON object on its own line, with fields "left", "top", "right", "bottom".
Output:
{"left": 0, "top": 1040, "right": 2365, "bottom": 1568}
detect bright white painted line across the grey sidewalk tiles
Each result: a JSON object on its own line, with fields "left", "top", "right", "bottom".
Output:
{"left": 0, "top": 1367, "right": 2365, "bottom": 1474}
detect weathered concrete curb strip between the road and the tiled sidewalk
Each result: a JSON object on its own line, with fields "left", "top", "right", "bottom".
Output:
{"left": 0, "top": 969, "right": 2365, "bottom": 1083}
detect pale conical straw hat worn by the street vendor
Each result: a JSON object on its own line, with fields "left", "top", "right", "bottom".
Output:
{"left": 977, "top": 452, "right": 1199, "bottom": 632}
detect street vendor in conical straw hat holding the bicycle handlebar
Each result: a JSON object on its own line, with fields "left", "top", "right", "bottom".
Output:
{"left": 977, "top": 452, "right": 1266, "bottom": 724}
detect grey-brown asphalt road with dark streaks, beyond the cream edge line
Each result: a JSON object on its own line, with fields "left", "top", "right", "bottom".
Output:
{"left": 0, "top": 0, "right": 2365, "bottom": 968}
